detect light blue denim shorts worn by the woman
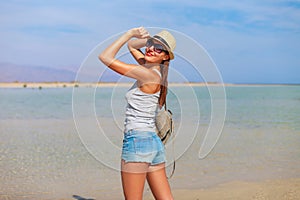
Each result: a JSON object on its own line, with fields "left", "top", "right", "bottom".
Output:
{"left": 122, "top": 130, "right": 166, "bottom": 165}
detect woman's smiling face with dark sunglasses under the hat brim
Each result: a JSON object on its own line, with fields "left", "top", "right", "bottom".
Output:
{"left": 145, "top": 39, "right": 169, "bottom": 63}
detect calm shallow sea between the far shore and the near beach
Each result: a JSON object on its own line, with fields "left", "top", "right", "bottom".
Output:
{"left": 0, "top": 85, "right": 300, "bottom": 199}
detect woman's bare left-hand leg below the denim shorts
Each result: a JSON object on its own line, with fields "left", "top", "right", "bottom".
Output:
{"left": 121, "top": 160, "right": 149, "bottom": 200}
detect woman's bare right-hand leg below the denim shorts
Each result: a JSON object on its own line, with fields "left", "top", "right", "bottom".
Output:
{"left": 147, "top": 163, "right": 173, "bottom": 200}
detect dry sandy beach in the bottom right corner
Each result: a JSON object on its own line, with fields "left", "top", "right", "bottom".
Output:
{"left": 164, "top": 179, "right": 300, "bottom": 200}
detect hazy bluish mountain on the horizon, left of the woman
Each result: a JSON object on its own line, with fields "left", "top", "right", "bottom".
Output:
{"left": 0, "top": 62, "right": 127, "bottom": 82}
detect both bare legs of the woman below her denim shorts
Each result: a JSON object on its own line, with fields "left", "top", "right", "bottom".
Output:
{"left": 121, "top": 160, "right": 173, "bottom": 200}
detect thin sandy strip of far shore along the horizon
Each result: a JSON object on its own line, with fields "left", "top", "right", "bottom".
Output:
{"left": 0, "top": 82, "right": 300, "bottom": 89}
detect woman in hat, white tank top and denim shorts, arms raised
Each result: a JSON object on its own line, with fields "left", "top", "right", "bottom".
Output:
{"left": 99, "top": 27, "right": 176, "bottom": 200}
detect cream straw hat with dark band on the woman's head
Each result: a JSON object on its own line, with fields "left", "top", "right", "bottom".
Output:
{"left": 152, "top": 30, "right": 176, "bottom": 60}
